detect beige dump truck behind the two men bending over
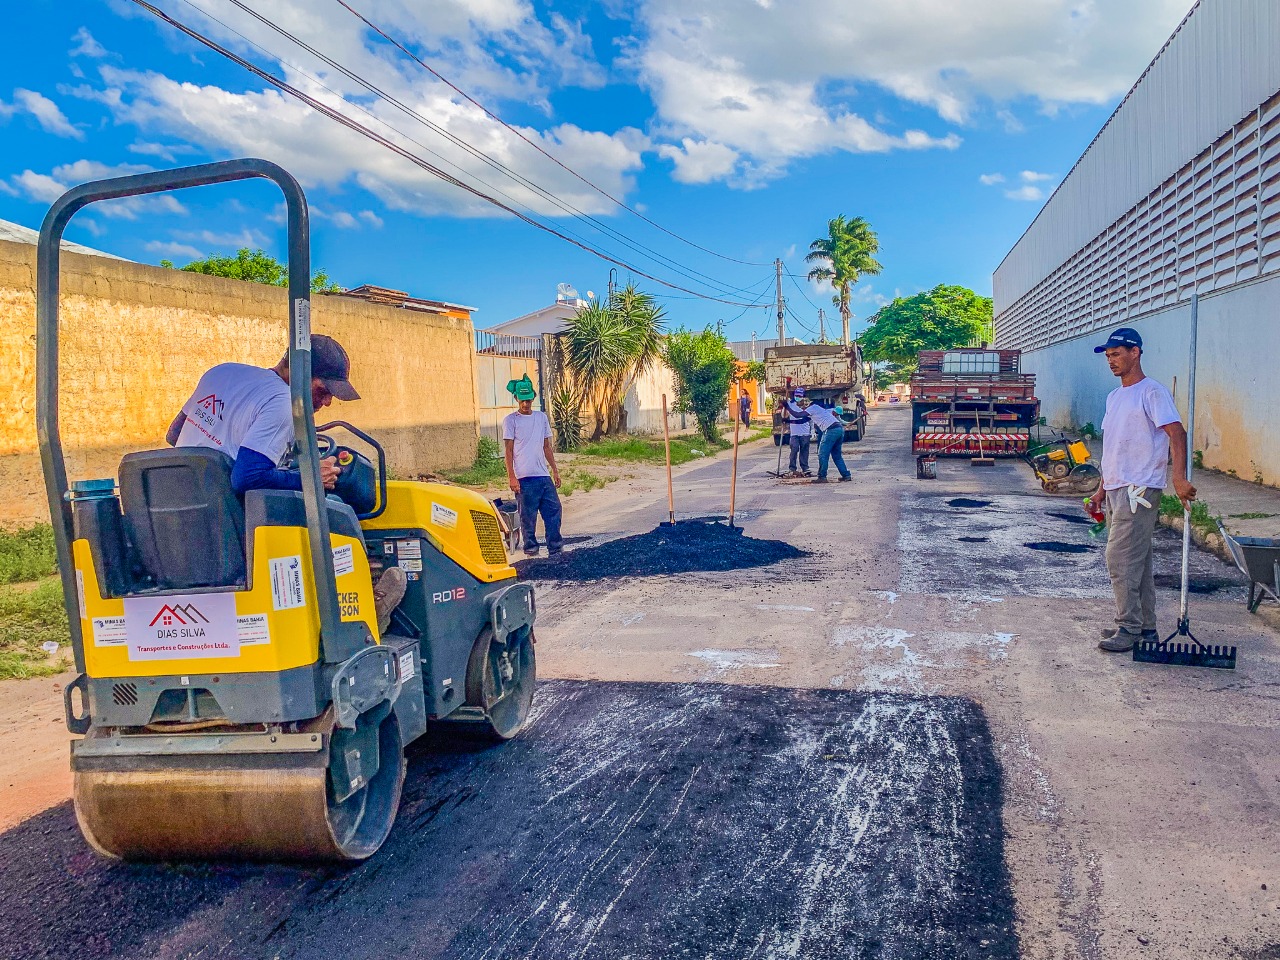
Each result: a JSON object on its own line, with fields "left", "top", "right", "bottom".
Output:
{"left": 764, "top": 343, "right": 867, "bottom": 445}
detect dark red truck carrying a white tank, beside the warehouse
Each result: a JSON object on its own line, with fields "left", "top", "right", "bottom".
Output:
{"left": 911, "top": 347, "right": 1039, "bottom": 458}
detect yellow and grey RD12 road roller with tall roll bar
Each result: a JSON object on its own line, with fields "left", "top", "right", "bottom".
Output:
{"left": 36, "top": 160, "right": 535, "bottom": 861}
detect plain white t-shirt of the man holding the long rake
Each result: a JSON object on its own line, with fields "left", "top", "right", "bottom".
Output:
{"left": 1102, "top": 376, "right": 1181, "bottom": 490}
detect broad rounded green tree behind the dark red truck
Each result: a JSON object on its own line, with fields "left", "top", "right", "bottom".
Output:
{"left": 860, "top": 284, "right": 992, "bottom": 375}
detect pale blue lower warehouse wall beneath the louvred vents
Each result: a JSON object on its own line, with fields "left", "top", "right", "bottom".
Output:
{"left": 1023, "top": 276, "right": 1280, "bottom": 486}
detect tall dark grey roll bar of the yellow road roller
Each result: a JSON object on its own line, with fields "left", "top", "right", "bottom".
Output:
{"left": 36, "top": 159, "right": 367, "bottom": 673}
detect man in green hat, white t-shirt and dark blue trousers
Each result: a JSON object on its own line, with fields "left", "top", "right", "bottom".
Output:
{"left": 502, "top": 374, "right": 564, "bottom": 557}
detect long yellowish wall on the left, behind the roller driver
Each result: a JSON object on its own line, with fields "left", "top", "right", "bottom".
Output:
{"left": 0, "top": 242, "right": 477, "bottom": 524}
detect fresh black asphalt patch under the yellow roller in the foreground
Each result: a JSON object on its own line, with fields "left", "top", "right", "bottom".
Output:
{"left": 0, "top": 681, "right": 1018, "bottom": 960}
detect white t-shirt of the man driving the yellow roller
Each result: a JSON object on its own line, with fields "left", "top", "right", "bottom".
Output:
{"left": 178, "top": 364, "right": 293, "bottom": 463}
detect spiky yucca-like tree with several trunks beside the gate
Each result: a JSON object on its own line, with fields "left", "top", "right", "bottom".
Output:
{"left": 563, "top": 283, "right": 664, "bottom": 440}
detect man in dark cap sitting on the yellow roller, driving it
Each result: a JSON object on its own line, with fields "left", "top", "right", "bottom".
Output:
{"left": 165, "top": 334, "right": 407, "bottom": 632}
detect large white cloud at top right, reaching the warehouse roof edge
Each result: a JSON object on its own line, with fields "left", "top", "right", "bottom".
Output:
{"left": 626, "top": 0, "right": 1188, "bottom": 184}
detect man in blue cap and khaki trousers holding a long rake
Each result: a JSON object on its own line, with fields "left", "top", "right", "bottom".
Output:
{"left": 1085, "top": 326, "right": 1196, "bottom": 653}
